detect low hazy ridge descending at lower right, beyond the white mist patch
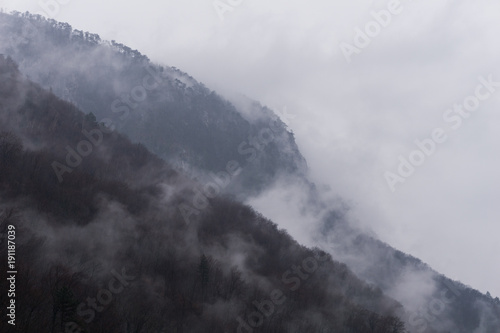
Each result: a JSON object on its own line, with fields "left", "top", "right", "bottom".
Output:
{"left": 318, "top": 215, "right": 500, "bottom": 333}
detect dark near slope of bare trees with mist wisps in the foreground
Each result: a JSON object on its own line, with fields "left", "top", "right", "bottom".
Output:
{"left": 0, "top": 56, "right": 404, "bottom": 333}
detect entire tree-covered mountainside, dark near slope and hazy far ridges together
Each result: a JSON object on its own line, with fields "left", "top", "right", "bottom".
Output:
{"left": 0, "top": 13, "right": 500, "bottom": 333}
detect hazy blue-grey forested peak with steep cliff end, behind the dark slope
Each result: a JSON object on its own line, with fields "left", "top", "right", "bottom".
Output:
{"left": 0, "top": 13, "right": 307, "bottom": 198}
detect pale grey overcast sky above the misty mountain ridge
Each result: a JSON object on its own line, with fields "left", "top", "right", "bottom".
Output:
{"left": 0, "top": 0, "right": 500, "bottom": 296}
